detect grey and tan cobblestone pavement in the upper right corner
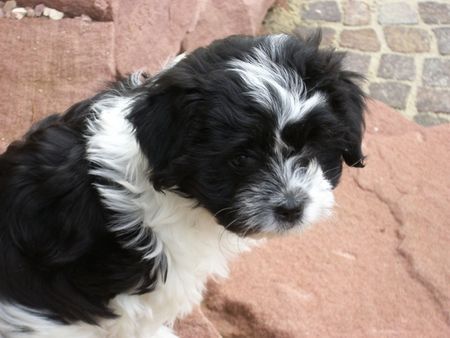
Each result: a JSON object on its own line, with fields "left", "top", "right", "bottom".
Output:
{"left": 264, "top": 0, "right": 450, "bottom": 125}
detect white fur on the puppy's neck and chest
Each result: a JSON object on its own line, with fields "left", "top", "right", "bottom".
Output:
{"left": 87, "top": 96, "right": 254, "bottom": 337}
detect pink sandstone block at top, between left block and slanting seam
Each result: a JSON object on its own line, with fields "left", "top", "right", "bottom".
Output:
{"left": 114, "top": 0, "right": 200, "bottom": 74}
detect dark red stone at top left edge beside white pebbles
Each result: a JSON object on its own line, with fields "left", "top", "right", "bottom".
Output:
{"left": 17, "top": 0, "right": 113, "bottom": 21}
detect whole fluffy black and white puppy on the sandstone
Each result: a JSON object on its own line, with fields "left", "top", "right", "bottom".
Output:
{"left": 0, "top": 35, "right": 364, "bottom": 338}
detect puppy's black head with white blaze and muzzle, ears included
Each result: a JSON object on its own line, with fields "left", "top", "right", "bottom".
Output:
{"left": 130, "top": 35, "right": 364, "bottom": 234}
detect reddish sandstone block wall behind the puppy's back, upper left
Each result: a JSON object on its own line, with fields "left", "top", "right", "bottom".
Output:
{"left": 0, "top": 0, "right": 274, "bottom": 148}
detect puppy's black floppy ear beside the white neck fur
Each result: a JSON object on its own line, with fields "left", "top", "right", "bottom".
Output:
{"left": 129, "top": 69, "right": 202, "bottom": 191}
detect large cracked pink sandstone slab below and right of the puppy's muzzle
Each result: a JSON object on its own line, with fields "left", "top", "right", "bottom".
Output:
{"left": 204, "top": 103, "right": 450, "bottom": 338}
